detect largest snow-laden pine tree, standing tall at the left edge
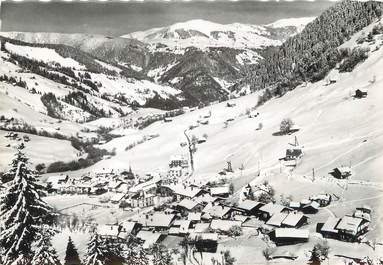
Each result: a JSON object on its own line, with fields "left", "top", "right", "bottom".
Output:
{"left": 0, "top": 144, "right": 54, "bottom": 265}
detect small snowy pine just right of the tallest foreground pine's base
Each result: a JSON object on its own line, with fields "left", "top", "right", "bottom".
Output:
{"left": 32, "top": 228, "right": 61, "bottom": 265}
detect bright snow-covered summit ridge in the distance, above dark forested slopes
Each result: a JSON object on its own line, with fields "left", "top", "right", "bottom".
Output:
{"left": 122, "top": 17, "right": 314, "bottom": 49}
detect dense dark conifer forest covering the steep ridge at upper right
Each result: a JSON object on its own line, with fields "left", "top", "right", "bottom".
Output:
{"left": 241, "top": 0, "right": 383, "bottom": 95}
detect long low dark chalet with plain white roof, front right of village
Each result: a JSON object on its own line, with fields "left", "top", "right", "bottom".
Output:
{"left": 269, "top": 228, "right": 309, "bottom": 246}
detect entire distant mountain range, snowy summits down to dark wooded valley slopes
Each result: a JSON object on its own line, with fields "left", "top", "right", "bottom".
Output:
{"left": 1, "top": 18, "right": 313, "bottom": 105}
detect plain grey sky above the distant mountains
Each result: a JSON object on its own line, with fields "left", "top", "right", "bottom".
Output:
{"left": 0, "top": 0, "right": 334, "bottom": 36}
